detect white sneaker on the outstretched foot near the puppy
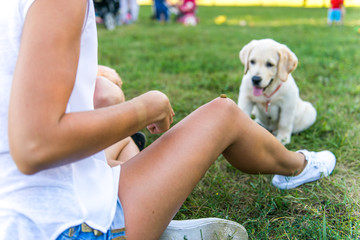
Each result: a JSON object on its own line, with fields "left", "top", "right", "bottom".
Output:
{"left": 272, "top": 150, "right": 336, "bottom": 189}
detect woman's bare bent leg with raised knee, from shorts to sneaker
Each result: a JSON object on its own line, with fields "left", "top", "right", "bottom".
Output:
{"left": 119, "top": 98, "right": 305, "bottom": 240}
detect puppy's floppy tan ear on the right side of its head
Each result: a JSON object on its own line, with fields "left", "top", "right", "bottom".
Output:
{"left": 278, "top": 44, "right": 298, "bottom": 82}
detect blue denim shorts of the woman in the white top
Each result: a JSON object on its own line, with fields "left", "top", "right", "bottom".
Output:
{"left": 56, "top": 199, "right": 126, "bottom": 240}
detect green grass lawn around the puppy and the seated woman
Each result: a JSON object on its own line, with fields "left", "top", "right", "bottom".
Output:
{"left": 98, "top": 6, "right": 360, "bottom": 239}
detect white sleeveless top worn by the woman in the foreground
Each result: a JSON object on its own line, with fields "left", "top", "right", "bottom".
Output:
{"left": 0, "top": 0, "right": 120, "bottom": 239}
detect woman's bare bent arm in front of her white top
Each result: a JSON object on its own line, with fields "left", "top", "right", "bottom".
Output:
{"left": 9, "top": 0, "right": 173, "bottom": 174}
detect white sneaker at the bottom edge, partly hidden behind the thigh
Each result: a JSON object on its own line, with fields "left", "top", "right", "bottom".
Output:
{"left": 160, "top": 218, "right": 248, "bottom": 240}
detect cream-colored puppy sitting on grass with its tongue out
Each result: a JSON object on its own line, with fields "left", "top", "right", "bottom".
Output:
{"left": 238, "top": 39, "right": 316, "bottom": 144}
